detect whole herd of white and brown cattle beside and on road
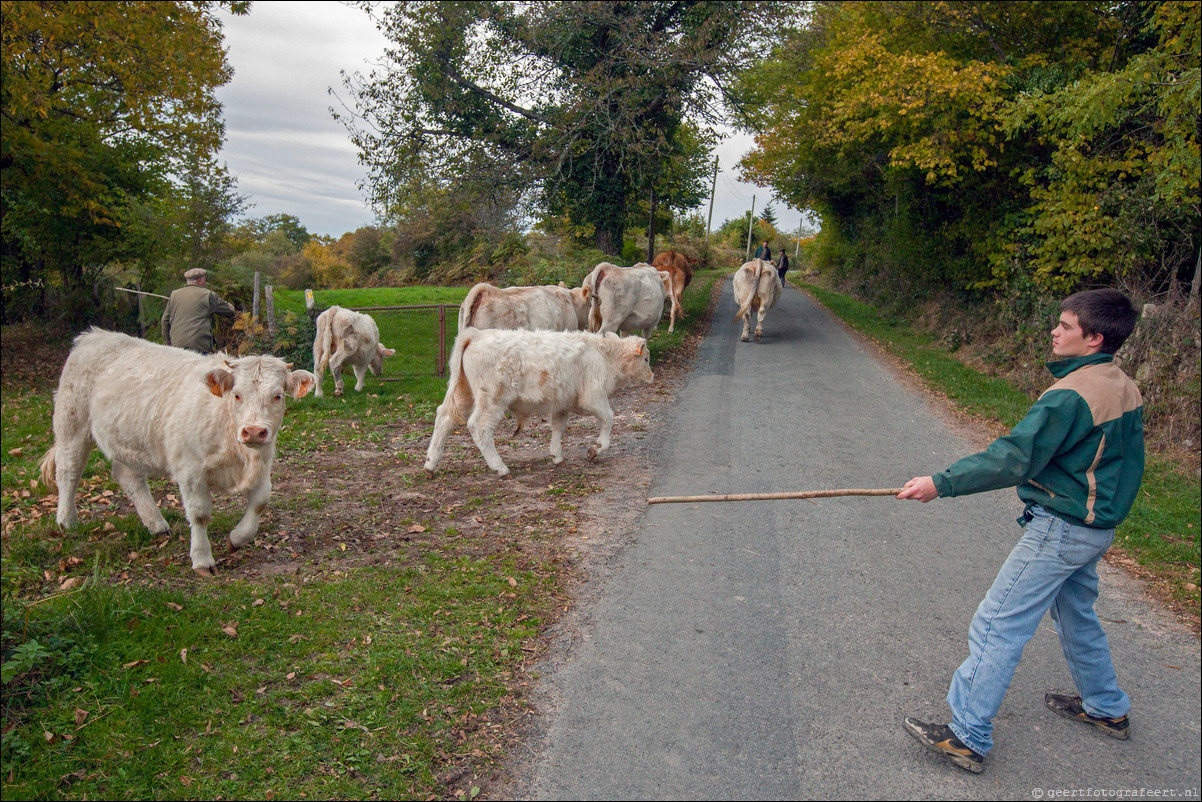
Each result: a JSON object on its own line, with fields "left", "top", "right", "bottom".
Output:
{"left": 40, "top": 251, "right": 781, "bottom": 576}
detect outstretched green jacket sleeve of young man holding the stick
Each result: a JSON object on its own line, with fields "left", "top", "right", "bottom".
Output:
{"left": 933, "top": 390, "right": 1094, "bottom": 497}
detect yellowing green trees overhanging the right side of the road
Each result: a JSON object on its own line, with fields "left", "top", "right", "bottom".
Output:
{"left": 738, "top": 1, "right": 1200, "bottom": 297}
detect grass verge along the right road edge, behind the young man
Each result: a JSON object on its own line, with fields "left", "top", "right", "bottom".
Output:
{"left": 801, "top": 284, "right": 1202, "bottom": 628}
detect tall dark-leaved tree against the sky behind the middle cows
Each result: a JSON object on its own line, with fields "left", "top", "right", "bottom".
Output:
{"left": 345, "top": 1, "right": 775, "bottom": 253}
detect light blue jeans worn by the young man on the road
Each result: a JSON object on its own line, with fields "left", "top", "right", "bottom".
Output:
{"left": 947, "top": 505, "right": 1131, "bottom": 755}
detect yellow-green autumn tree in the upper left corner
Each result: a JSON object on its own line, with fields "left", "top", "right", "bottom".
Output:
{"left": 0, "top": 1, "right": 249, "bottom": 319}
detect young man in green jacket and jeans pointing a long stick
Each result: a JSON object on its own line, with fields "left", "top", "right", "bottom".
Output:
{"left": 897, "top": 290, "right": 1143, "bottom": 772}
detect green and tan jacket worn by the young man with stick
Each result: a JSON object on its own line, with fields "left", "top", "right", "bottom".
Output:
{"left": 933, "top": 354, "right": 1143, "bottom": 529}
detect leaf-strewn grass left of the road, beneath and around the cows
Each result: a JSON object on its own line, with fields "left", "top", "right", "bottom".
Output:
{"left": 0, "top": 272, "right": 720, "bottom": 800}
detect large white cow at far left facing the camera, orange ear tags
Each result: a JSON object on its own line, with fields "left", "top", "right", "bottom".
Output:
{"left": 40, "top": 328, "right": 316, "bottom": 576}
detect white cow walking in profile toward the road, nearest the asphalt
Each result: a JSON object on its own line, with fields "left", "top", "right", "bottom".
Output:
{"left": 426, "top": 328, "right": 655, "bottom": 479}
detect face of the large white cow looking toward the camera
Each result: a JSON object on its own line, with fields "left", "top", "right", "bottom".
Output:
{"left": 204, "top": 356, "right": 317, "bottom": 448}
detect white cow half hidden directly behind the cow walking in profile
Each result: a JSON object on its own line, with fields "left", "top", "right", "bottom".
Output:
{"left": 459, "top": 283, "right": 589, "bottom": 332}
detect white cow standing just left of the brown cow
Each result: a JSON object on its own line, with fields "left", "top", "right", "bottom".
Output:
{"left": 584, "top": 262, "right": 674, "bottom": 338}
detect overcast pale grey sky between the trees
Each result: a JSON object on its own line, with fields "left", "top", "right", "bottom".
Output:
{"left": 216, "top": 0, "right": 801, "bottom": 238}
